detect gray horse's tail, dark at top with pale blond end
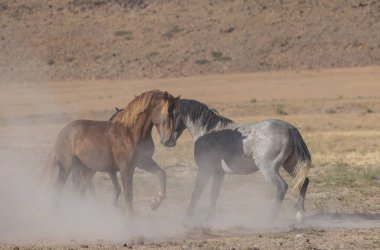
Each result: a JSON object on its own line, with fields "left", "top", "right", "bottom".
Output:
{"left": 290, "top": 127, "right": 312, "bottom": 194}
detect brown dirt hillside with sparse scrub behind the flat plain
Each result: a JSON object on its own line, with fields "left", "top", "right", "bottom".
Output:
{"left": 0, "top": 0, "right": 380, "bottom": 82}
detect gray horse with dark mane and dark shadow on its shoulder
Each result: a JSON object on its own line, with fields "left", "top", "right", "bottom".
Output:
{"left": 174, "top": 99, "right": 311, "bottom": 221}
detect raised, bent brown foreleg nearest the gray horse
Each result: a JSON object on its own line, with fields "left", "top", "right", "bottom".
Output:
{"left": 139, "top": 158, "right": 167, "bottom": 211}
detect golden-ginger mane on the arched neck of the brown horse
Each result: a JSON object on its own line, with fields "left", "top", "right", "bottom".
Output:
{"left": 110, "top": 90, "right": 164, "bottom": 127}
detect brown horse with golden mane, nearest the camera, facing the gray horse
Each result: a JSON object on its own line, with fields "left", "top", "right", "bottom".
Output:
{"left": 46, "top": 90, "right": 179, "bottom": 215}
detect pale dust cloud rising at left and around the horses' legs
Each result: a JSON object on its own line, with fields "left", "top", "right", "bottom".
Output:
{"left": 0, "top": 99, "right": 284, "bottom": 242}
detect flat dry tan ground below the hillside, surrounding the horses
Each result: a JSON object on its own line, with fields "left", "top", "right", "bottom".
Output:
{"left": 0, "top": 67, "right": 380, "bottom": 249}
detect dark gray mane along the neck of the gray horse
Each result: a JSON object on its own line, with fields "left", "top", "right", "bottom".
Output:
{"left": 178, "top": 99, "right": 233, "bottom": 132}
